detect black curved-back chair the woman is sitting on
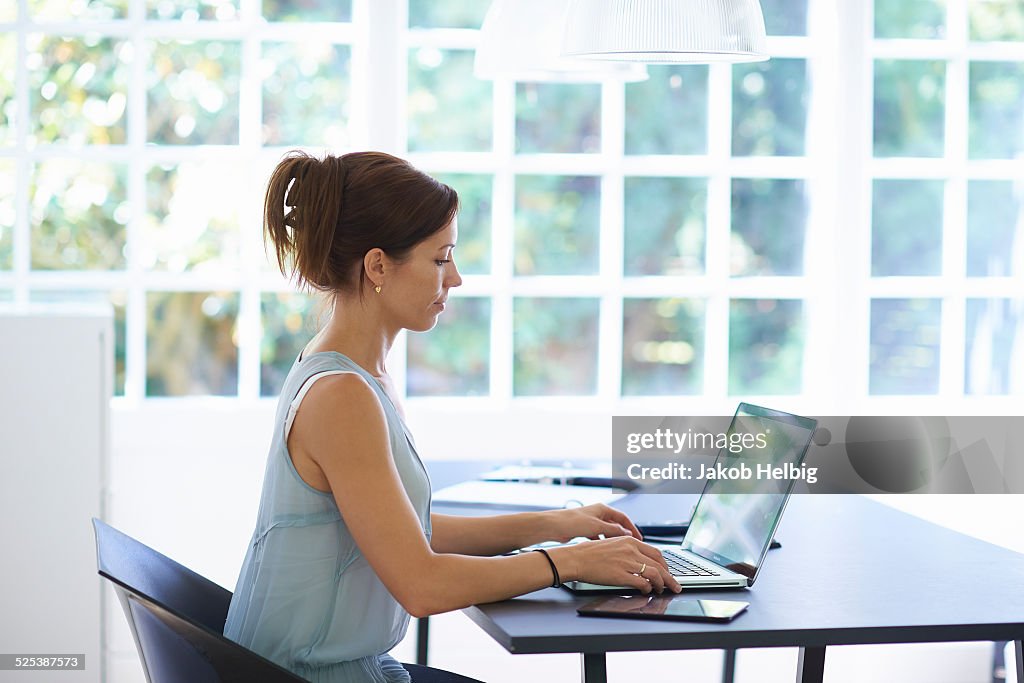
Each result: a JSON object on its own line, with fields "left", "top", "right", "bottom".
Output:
{"left": 92, "top": 518, "right": 479, "bottom": 683}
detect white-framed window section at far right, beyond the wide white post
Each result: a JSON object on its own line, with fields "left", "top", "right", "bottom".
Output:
{"left": 868, "top": 0, "right": 1024, "bottom": 396}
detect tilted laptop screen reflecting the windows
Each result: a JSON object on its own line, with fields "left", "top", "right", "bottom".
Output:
{"left": 683, "top": 403, "right": 817, "bottom": 579}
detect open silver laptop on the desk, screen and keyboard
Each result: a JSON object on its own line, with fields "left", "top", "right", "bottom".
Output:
{"left": 564, "top": 403, "right": 817, "bottom": 593}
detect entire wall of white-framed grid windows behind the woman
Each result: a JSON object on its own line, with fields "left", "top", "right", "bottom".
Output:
{"left": 0, "top": 0, "right": 1024, "bottom": 412}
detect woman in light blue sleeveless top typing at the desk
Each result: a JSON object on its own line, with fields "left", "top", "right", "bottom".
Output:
{"left": 224, "top": 153, "right": 680, "bottom": 681}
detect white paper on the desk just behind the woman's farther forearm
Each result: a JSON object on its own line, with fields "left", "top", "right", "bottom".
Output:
{"left": 433, "top": 481, "right": 623, "bottom": 510}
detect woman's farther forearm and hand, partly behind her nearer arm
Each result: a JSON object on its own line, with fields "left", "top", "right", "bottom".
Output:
{"left": 430, "top": 504, "right": 640, "bottom": 555}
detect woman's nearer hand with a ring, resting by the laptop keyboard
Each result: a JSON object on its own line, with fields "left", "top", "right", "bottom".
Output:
{"left": 548, "top": 536, "right": 683, "bottom": 593}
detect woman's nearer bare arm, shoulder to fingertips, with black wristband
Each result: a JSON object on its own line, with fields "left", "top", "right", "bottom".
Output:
{"left": 289, "top": 374, "right": 678, "bottom": 616}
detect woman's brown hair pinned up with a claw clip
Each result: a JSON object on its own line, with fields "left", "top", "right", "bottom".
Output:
{"left": 263, "top": 151, "right": 459, "bottom": 294}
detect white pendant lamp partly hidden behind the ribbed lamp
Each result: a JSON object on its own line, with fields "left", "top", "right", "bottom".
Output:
{"left": 473, "top": 0, "right": 647, "bottom": 82}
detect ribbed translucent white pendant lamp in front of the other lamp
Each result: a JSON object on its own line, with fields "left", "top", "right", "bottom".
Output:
{"left": 562, "top": 0, "right": 768, "bottom": 63}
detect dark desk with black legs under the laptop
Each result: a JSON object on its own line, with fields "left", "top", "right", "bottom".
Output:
{"left": 465, "top": 496, "right": 1024, "bottom": 683}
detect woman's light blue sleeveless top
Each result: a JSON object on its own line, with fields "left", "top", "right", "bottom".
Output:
{"left": 224, "top": 351, "right": 430, "bottom": 683}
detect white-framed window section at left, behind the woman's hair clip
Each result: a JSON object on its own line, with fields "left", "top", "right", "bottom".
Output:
{"left": 0, "top": 0, "right": 359, "bottom": 399}
